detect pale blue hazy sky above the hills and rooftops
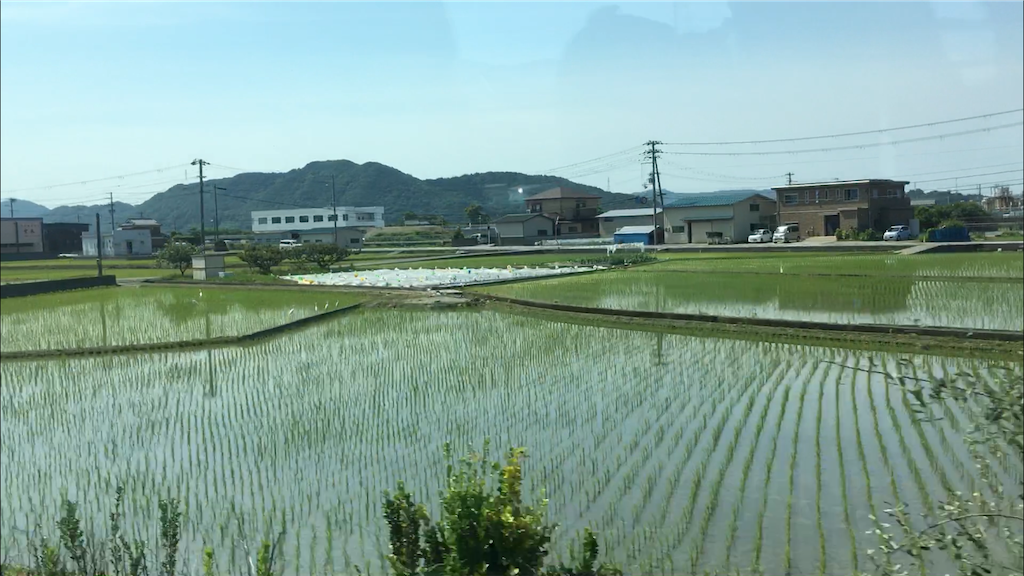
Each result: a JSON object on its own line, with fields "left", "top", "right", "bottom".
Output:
{"left": 0, "top": 0, "right": 1024, "bottom": 207}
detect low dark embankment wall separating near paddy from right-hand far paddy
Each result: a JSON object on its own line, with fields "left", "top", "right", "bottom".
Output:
{"left": 481, "top": 294, "right": 1024, "bottom": 342}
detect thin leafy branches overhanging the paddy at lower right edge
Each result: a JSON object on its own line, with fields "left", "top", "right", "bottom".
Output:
{"left": 867, "top": 365, "right": 1024, "bottom": 576}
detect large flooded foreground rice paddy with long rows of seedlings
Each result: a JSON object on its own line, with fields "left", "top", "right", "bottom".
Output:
{"left": 0, "top": 311, "right": 1019, "bottom": 574}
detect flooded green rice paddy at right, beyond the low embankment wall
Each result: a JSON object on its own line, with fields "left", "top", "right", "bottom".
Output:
{"left": 481, "top": 266, "right": 1024, "bottom": 330}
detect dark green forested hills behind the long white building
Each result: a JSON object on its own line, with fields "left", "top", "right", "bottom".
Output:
{"left": 37, "top": 160, "right": 632, "bottom": 231}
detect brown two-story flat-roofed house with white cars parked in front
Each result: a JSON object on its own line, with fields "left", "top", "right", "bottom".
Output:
{"left": 772, "top": 178, "right": 913, "bottom": 238}
